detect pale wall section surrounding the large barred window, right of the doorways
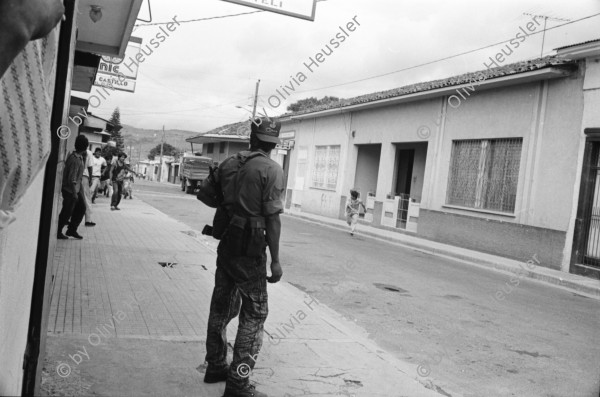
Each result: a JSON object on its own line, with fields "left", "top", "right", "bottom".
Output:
{"left": 428, "top": 74, "right": 583, "bottom": 231}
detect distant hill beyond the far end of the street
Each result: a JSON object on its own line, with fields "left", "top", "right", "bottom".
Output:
{"left": 121, "top": 124, "right": 201, "bottom": 159}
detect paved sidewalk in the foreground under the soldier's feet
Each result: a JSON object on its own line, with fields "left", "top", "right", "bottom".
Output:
{"left": 42, "top": 197, "right": 442, "bottom": 397}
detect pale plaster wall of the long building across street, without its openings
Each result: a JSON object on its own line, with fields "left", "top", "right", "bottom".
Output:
{"left": 288, "top": 72, "right": 584, "bottom": 232}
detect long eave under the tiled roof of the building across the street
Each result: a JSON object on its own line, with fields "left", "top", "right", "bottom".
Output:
{"left": 288, "top": 67, "right": 572, "bottom": 122}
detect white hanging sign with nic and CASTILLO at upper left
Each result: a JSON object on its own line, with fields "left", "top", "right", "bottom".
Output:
{"left": 94, "top": 37, "right": 142, "bottom": 92}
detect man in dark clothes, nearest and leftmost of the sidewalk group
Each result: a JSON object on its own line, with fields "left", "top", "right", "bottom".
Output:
{"left": 57, "top": 135, "right": 89, "bottom": 240}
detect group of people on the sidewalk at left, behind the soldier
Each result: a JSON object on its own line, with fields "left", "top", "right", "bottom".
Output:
{"left": 57, "top": 135, "right": 134, "bottom": 240}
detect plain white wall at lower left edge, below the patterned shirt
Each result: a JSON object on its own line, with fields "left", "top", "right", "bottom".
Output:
{"left": 0, "top": 171, "right": 44, "bottom": 396}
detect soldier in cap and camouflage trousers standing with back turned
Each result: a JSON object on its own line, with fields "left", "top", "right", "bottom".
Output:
{"left": 204, "top": 118, "right": 284, "bottom": 397}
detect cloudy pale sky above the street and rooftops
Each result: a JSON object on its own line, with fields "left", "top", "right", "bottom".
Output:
{"left": 90, "top": 0, "right": 600, "bottom": 132}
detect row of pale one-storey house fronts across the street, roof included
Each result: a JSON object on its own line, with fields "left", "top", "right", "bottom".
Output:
{"left": 282, "top": 42, "right": 600, "bottom": 275}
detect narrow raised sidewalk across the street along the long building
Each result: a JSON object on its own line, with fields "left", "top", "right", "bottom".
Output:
{"left": 286, "top": 211, "right": 600, "bottom": 299}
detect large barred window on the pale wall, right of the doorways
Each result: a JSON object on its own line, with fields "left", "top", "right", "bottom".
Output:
{"left": 446, "top": 138, "right": 523, "bottom": 213}
